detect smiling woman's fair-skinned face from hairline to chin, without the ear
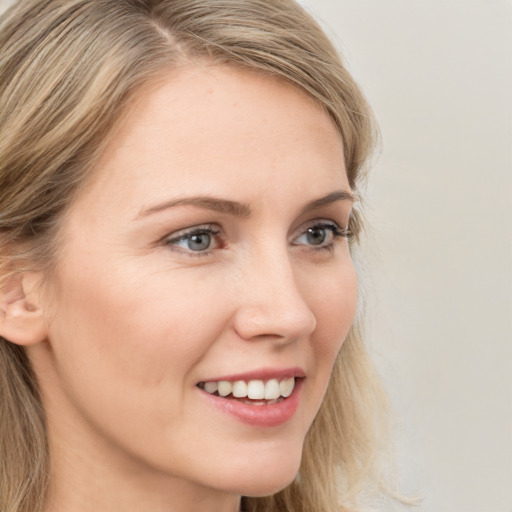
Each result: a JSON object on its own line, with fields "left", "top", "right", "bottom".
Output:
{"left": 33, "top": 66, "right": 357, "bottom": 495}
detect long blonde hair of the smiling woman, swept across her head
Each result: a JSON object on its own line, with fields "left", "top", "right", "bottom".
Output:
{"left": 0, "top": 0, "right": 385, "bottom": 512}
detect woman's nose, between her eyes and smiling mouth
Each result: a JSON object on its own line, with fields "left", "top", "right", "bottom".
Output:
{"left": 234, "top": 251, "right": 316, "bottom": 344}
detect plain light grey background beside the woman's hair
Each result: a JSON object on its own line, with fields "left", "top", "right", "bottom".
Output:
{"left": 0, "top": 0, "right": 512, "bottom": 512}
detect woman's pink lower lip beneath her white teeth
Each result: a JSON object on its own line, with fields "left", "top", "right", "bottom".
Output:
{"left": 201, "top": 379, "right": 303, "bottom": 427}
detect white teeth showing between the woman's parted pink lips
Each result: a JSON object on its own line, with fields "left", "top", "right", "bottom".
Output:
{"left": 197, "top": 377, "right": 295, "bottom": 405}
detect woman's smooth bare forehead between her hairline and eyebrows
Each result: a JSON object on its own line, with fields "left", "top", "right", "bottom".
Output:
{"left": 70, "top": 65, "right": 345, "bottom": 216}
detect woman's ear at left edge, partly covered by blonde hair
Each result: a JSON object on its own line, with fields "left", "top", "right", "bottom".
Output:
{"left": 0, "top": 272, "right": 47, "bottom": 346}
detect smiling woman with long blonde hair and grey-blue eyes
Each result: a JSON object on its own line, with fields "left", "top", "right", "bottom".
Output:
{"left": 0, "top": 0, "right": 383, "bottom": 512}
